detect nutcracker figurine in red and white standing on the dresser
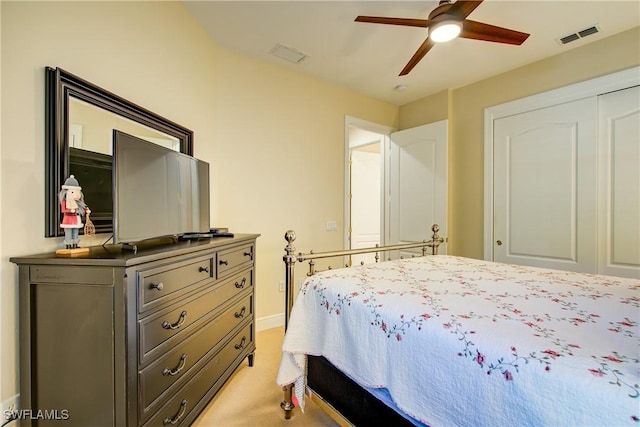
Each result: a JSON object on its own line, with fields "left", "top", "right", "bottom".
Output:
{"left": 58, "top": 175, "right": 91, "bottom": 249}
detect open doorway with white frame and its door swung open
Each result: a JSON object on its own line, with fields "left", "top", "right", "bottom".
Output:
{"left": 344, "top": 117, "right": 448, "bottom": 264}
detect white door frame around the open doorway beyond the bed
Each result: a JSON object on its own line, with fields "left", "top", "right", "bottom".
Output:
{"left": 342, "top": 116, "right": 396, "bottom": 249}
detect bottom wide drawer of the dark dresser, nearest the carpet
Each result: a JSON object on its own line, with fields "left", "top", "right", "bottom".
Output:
{"left": 144, "top": 323, "right": 255, "bottom": 427}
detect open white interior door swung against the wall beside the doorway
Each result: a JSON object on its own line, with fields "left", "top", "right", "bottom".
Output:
{"left": 385, "top": 120, "right": 448, "bottom": 254}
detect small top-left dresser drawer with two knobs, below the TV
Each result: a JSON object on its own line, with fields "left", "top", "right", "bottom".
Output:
{"left": 138, "top": 256, "right": 214, "bottom": 312}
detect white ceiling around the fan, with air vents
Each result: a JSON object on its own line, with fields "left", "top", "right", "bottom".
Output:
{"left": 183, "top": 0, "right": 640, "bottom": 105}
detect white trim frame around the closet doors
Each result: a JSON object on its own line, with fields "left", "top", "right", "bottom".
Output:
{"left": 484, "top": 66, "right": 640, "bottom": 261}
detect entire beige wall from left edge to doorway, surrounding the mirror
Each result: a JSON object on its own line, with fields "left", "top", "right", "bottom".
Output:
{"left": 0, "top": 1, "right": 398, "bottom": 401}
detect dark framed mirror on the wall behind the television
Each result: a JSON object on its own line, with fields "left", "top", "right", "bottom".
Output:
{"left": 45, "top": 67, "right": 193, "bottom": 237}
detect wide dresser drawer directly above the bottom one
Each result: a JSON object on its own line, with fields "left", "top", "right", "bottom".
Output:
{"left": 139, "top": 294, "right": 253, "bottom": 414}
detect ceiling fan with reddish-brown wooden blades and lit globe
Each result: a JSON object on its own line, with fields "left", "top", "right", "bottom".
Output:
{"left": 356, "top": 0, "right": 529, "bottom": 76}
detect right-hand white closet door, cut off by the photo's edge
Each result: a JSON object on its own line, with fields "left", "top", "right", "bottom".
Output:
{"left": 598, "top": 86, "right": 640, "bottom": 278}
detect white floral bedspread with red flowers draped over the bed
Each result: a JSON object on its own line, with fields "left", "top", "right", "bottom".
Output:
{"left": 277, "top": 255, "right": 640, "bottom": 426}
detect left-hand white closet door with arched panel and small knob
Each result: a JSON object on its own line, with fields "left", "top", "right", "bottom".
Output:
{"left": 493, "top": 97, "right": 597, "bottom": 272}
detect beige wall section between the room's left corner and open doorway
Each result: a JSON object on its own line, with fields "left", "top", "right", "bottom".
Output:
{"left": 212, "top": 47, "right": 397, "bottom": 332}
